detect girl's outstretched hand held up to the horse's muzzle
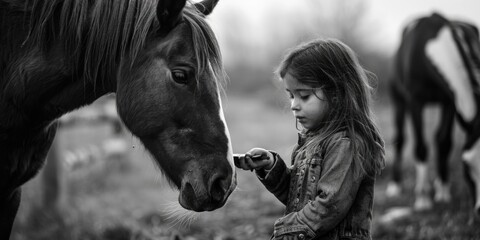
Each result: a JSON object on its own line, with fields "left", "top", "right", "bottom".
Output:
{"left": 239, "top": 148, "right": 275, "bottom": 170}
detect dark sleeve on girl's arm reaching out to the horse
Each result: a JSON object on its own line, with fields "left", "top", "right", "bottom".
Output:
{"left": 256, "top": 152, "right": 291, "bottom": 205}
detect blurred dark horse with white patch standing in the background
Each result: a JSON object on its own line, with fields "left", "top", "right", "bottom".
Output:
{"left": 387, "top": 13, "right": 480, "bottom": 215}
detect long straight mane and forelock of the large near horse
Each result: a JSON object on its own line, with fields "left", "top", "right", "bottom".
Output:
{"left": 6, "top": 0, "right": 224, "bottom": 88}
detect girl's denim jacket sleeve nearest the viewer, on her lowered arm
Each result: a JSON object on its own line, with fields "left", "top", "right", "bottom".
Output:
{"left": 274, "top": 138, "right": 361, "bottom": 239}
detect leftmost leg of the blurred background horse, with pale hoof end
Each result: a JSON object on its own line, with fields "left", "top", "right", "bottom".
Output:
{"left": 386, "top": 82, "right": 406, "bottom": 197}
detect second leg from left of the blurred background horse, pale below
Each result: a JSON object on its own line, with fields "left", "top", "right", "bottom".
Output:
{"left": 412, "top": 104, "right": 433, "bottom": 210}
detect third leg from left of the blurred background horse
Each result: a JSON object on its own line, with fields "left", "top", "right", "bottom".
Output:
{"left": 434, "top": 104, "right": 455, "bottom": 202}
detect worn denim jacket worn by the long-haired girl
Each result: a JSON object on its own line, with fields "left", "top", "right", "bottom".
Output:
{"left": 257, "top": 132, "right": 375, "bottom": 240}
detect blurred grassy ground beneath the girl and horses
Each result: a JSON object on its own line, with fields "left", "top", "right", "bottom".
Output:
{"left": 12, "top": 96, "right": 480, "bottom": 240}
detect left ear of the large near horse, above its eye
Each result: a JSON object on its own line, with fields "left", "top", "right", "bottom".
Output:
{"left": 157, "top": 0, "right": 187, "bottom": 33}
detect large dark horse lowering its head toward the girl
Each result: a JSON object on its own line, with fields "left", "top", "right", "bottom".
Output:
{"left": 0, "top": 0, "right": 236, "bottom": 239}
